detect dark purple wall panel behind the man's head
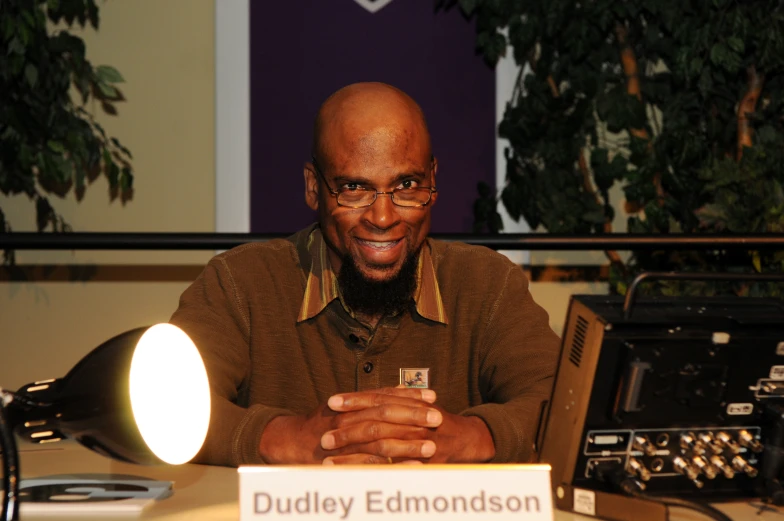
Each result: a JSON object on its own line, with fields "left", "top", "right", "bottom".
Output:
{"left": 250, "top": 0, "right": 495, "bottom": 233}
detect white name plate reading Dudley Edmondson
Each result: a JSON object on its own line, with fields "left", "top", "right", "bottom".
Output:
{"left": 239, "top": 465, "right": 553, "bottom": 521}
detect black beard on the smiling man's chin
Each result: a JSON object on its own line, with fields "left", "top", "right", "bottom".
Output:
{"left": 338, "top": 249, "right": 419, "bottom": 317}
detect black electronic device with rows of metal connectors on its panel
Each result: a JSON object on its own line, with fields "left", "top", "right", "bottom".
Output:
{"left": 537, "top": 280, "right": 784, "bottom": 521}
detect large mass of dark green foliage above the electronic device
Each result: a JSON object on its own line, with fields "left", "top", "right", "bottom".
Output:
{"left": 444, "top": 0, "right": 784, "bottom": 295}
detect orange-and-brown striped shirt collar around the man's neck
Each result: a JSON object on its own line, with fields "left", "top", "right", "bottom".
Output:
{"left": 297, "top": 227, "right": 447, "bottom": 324}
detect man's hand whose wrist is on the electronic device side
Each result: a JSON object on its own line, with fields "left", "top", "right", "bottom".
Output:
{"left": 321, "top": 391, "right": 495, "bottom": 464}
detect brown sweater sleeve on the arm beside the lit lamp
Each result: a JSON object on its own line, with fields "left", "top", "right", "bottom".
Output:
{"left": 170, "top": 256, "right": 292, "bottom": 466}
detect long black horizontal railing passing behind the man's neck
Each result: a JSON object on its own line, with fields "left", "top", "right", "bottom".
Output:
{"left": 0, "top": 232, "right": 784, "bottom": 251}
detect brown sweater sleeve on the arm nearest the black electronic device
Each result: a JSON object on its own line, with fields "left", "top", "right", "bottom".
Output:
{"left": 461, "top": 266, "right": 560, "bottom": 463}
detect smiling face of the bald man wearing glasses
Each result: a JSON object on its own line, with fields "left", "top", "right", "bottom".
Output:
{"left": 305, "top": 118, "right": 437, "bottom": 281}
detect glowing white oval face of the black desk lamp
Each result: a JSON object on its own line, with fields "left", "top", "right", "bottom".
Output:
{"left": 130, "top": 324, "right": 210, "bottom": 465}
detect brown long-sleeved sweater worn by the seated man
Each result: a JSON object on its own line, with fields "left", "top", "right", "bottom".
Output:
{"left": 171, "top": 222, "right": 559, "bottom": 466}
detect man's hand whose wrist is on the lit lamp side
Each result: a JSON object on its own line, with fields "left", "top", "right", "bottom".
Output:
{"left": 259, "top": 388, "right": 443, "bottom": 464}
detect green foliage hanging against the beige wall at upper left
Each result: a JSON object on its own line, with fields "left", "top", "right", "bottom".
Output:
{"left": 0, "top": 0, "right": 133, "bottom": 261}
